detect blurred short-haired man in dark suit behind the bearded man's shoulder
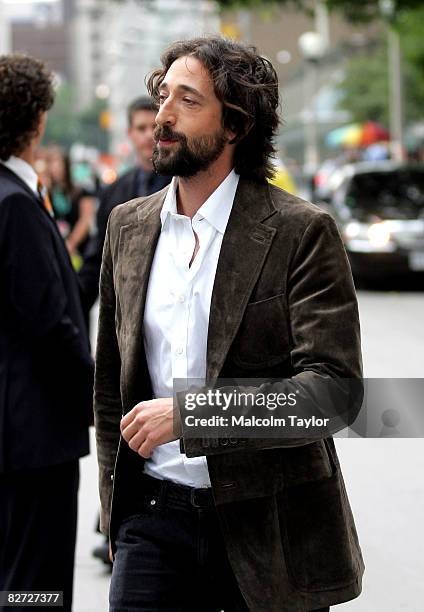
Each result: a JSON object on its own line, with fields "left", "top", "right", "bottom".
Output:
{"left": 79, "top": 96, "right": 172, "bottom": 311}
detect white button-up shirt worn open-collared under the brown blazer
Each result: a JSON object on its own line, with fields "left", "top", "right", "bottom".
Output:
{"left": 143, "top": 170, "right": 239, "bottom": 487}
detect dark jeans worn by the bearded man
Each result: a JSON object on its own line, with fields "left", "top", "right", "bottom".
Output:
{"left": 109, "top": 474, "right": 329, "bottom": 612}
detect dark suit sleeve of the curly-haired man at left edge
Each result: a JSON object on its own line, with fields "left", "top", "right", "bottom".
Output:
{"left": 0, "top": 193, "right": 92, "bottom": 370}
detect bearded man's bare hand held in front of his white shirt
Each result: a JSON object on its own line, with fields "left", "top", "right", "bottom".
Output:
{"left": 121, "top": 397, "right": 181, "bottom": 459}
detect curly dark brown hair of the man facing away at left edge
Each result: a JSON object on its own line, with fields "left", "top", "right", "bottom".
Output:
{"left": 0, "top": 53, "right": 54, "bottom": 161}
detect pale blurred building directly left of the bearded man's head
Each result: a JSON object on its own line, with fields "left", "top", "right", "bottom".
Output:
{"left": 90, "top": 0, "right": 219, "bottom": 160}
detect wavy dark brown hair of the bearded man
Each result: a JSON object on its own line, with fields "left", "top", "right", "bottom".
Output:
{"left": 146, "top": 36, "right": 280, "bottom": 182}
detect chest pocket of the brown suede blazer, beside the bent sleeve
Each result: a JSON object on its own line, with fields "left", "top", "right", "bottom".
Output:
{"left": 232, "top": 293, "right": 291, "bottom": 369}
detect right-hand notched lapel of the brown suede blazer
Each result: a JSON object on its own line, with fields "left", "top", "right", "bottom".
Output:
{"left": 206, "top": 178, "right": 276, "bottom": 384}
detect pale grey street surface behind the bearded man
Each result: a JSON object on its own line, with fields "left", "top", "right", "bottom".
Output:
{"left": 74, "top": 287, "right": 424, "bottom": 612}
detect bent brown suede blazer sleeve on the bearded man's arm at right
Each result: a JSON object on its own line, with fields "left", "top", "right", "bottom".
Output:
{"left": 176, "top": 212, "right": 363, "bottom": 457}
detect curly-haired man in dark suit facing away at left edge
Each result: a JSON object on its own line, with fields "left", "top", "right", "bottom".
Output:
{"left": 0, "top": 54, "right": 93, "bottom": 611}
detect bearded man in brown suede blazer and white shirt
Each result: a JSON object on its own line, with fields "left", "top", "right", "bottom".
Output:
{"left": 95, "top": 37, "right": 364, "bottom": 612}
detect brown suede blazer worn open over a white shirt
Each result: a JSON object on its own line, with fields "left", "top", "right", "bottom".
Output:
{"left": 94, "top": 179, "right": 364, "bottom": 612}
